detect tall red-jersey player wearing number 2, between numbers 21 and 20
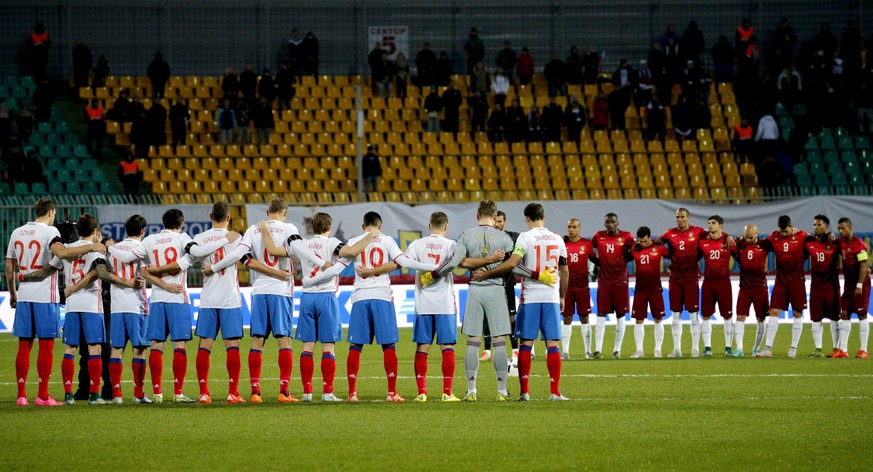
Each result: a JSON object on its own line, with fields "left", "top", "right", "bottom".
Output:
{"left": 659, "top": 208, "right": 706, "bottom": 357}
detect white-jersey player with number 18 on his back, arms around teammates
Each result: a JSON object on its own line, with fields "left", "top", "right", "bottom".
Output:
{"left": 109, "top": 208, "right": 232, "bottom": 403}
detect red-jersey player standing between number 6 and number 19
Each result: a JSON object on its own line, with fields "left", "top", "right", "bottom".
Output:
{"left": 758, "top": 215, "right": 809, "bottom": 357}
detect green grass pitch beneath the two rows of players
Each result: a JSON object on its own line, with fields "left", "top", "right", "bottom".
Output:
{"left": 0, "top": 323, "right": 873, "bottom": 471}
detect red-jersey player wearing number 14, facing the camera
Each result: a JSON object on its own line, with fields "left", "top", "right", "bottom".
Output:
{"left": 591, "top": 213, "right": 634, "bottom": 359}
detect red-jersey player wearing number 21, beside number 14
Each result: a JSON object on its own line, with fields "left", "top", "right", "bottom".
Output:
{"left": 625, "top": 226, "right": 670, "bottom": 359}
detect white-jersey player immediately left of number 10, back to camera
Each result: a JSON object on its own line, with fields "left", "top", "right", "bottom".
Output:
{"left": 258, "top": 213, "right": 373, "bottom": 402}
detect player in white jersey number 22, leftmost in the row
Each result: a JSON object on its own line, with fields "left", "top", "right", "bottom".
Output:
{"left": 6, "top": 198, "right": 106, "bottom": 406}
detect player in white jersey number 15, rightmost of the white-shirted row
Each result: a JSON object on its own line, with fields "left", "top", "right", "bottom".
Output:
{"left": 474, "top": 203, "right": 570, "bottom": 401}
